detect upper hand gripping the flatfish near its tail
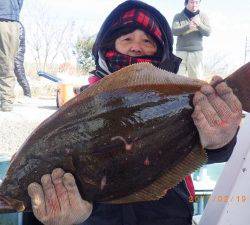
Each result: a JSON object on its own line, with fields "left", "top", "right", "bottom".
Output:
{"left": 192, "top": 77, "right": 242, "bottom": 149}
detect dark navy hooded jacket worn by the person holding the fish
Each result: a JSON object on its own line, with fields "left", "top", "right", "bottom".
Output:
{"left": 82, "top": 0, "right": 236, "bottom": 225}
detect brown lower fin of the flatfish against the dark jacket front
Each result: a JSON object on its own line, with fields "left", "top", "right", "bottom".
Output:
{"left": 108, "top": 145, "right": 207, "bottom": 204}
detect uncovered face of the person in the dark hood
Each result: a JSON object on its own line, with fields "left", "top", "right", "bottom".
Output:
{"left": 115, "top": 29, "right": 157, "bottom": 57}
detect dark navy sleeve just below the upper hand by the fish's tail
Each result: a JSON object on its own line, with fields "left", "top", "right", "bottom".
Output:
{"left": 206, "top": 134, "right": 237, "bottom": 164}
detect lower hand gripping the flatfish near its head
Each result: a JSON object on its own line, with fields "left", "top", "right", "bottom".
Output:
{"left": 28, "top": 168, "right": 92, "bottom": 225}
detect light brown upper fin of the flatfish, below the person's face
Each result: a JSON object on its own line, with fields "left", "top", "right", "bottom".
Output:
{"left": 67, "top": 62, "right": 206, "bottom": 106}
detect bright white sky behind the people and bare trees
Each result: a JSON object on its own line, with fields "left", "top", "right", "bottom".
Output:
{"left": 21, "top": 0, "right": 250, "bottom": 72}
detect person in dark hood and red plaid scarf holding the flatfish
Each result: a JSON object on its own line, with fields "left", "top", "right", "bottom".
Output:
{"left": 28, "top": 0, "right": 241, "bottom": 225}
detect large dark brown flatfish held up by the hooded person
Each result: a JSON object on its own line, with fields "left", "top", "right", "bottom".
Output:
{"left": 0, "top": 63, "right": 250, "bottom": 212}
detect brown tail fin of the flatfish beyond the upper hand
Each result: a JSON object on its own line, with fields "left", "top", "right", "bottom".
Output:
{"left": 225, "top": 62, "right": 250, "bottom": 112}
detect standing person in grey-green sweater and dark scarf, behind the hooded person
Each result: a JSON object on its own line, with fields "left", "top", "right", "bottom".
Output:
{"left": 172, "top": 0, "right": 211, "bottom": 79}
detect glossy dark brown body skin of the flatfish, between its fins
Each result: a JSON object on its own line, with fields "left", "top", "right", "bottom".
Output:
{"left": 0, "top": 86, "right": 199, "bottom": 210}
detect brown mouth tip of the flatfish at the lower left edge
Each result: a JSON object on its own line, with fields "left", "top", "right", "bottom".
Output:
{"left": 0, "top": 194, "right": 25, "bottom": 213}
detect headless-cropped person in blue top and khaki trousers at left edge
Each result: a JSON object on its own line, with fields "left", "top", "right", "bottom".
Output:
{"left": 0, "top": 0, "right": 23, "bottom": 112}
